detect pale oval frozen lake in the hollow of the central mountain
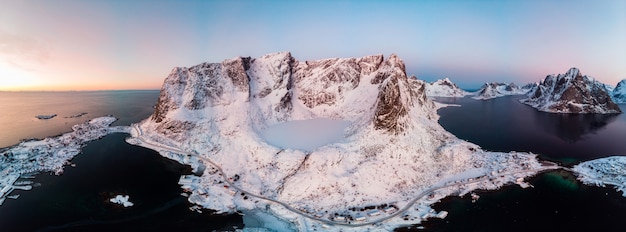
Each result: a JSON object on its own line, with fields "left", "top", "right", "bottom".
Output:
{"left": 260, "top": 118, "right": 350, "bottom": 151}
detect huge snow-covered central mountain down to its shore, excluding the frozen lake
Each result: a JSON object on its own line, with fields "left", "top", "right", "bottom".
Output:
{"left": 127, "top": 52, "right": 558, "bottom": 231}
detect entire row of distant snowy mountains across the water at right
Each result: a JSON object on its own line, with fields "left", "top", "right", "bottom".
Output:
{"left": 426, "top": 68, "right": 626, "bottom": 114}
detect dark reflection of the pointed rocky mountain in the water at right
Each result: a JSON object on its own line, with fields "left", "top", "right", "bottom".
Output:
{"left": 534, "top": 112, "right": 618, "bottom": 143}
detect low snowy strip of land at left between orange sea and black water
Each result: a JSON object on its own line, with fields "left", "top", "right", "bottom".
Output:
{"left": 0, "top": 116, "right": 128, "bottom": 205}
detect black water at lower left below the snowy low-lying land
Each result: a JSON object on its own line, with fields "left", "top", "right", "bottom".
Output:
{"left": 0, "top": 133, "right": 242, "bottom": 232}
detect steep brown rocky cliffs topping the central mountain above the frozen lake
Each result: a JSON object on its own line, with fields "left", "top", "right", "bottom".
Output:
{"left": 151, "top": 53, "right": 434, "bottom": 137}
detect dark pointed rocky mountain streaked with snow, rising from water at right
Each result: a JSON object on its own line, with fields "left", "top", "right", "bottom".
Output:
{"left": 520, "top": 68, "right": 622, "bottom": 114}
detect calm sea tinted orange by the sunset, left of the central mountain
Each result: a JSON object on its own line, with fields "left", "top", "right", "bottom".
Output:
{"left": 0, "top": 90, "right": 159, "bottom": 147}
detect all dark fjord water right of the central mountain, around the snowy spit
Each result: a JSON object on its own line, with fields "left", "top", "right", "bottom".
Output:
{"left": 412, "top": 96, "right": 626, "bottom": 231}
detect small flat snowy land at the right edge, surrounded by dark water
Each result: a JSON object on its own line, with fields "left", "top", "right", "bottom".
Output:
{"left": 572, "top": 156, "right": 626, "bottom": 197}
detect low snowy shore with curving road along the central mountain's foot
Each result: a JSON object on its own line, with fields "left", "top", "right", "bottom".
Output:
{"left": 128, "top": 121, "right": 560, "bottom": 231}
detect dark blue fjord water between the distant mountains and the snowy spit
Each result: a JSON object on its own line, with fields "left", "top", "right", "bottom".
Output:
{"left": 438, "top": 96, "right": 626, "bottom": 165}
